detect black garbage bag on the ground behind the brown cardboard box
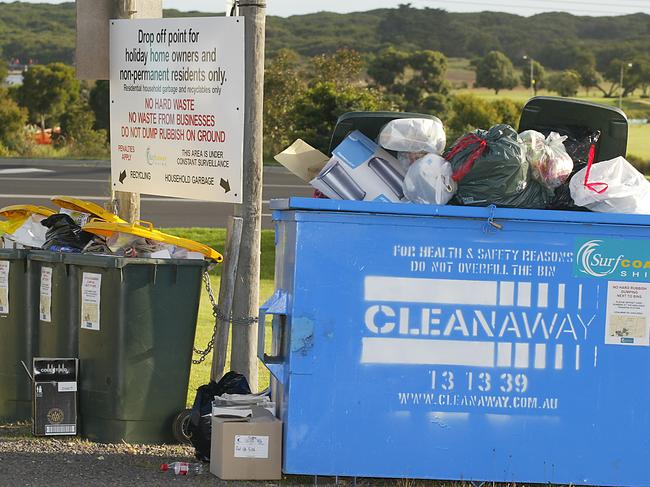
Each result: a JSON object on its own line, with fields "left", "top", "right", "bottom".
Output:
{"left": 187, "top": 371, "right": 251, "bottom": 462}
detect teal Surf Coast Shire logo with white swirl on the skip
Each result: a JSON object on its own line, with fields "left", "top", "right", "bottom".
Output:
{"left": 576, "top": 240, "right": 650, "bottom": 278}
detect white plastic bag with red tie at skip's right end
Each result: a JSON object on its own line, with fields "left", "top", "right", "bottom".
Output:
{"left": 569, "top": 157, "right": 650, "bottom": 215}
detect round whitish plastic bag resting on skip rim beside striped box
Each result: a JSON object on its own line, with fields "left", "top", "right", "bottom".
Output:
{"left": 404, "top": 154, "right": 457, "bottom": 205}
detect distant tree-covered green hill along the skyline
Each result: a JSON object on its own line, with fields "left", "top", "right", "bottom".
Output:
{"left": 0, "top": 2, "right": 650, "bottom": 69}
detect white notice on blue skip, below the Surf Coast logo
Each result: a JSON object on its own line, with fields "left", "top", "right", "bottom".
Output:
{"left": 605, "top": 281, "right": 650, "bottom": 346}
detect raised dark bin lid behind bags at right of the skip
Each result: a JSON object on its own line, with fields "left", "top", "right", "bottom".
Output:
{"left": 519, "top": 96, "right": 628, "bottom": 162}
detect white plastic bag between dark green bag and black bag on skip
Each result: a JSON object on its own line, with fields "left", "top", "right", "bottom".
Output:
{"left": 519, "top": 130, "right": 573, "bottom": 189}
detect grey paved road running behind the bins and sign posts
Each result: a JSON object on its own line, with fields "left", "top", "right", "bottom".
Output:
{"left": 0, "top": 159, "right": 312, "bottom": 228}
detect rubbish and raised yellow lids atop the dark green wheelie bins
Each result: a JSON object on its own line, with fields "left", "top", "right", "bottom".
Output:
{"left": 0, "top": 196, "right": 223, "bottom": 262}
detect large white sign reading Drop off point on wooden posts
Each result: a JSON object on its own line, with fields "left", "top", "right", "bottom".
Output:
{"left": 110, "top": 17, "right": 244, "bottom": 203}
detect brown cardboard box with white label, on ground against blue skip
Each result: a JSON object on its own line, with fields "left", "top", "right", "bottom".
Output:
{"left": 210, "top": 407, "right": 282, "bottom": 480}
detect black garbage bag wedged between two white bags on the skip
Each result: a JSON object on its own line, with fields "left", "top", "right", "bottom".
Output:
{"left": 549, "top": 127, "right": 600, "bottom": 211}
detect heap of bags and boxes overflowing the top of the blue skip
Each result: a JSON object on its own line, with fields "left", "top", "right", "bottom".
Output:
{"left": 276, "top": 104, "right": 650, "bottom": 214}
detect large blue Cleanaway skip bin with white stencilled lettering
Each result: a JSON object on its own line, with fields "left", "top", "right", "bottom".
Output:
{"left": 259, "top": 198, "right": 650, "bottom": 486}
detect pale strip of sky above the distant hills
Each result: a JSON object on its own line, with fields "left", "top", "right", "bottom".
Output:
{"left": 5, "top": 0, "right": 650, "bottom": 17}
